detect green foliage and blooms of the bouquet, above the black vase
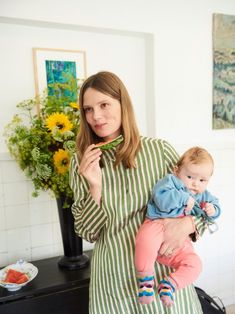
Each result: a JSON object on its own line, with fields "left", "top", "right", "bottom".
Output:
{"left": 4, "top": 84, "right": 80, "bottom": 197}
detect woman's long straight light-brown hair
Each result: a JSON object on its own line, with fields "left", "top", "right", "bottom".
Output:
{"left": 77, "top": 72, "right": 140, "bottom": 168}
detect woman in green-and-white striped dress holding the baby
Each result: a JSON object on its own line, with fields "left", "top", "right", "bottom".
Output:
{"left": 70, "top": 72, "right": 204, "bottom": 314}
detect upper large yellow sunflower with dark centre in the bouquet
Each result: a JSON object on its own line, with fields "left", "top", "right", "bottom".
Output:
{"left": 46, "top": 112, "right": 73, "bottom": 133}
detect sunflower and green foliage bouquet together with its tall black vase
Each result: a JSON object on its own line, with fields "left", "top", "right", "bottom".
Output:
{"left": 4, "top": 79, "right": 89, "bottom": 270}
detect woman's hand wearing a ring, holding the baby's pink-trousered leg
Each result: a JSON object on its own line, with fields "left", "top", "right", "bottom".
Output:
{"left": 159, "top": 216, "right": 195, "bottom": 256}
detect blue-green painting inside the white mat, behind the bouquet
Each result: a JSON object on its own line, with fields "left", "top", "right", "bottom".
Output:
{"left": 46, "top": 60, "right": 77, "bottom": 102}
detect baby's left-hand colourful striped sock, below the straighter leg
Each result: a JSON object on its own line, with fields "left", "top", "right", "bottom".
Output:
{"left": 137, "top": 273, "right": 154, "bottom": 304}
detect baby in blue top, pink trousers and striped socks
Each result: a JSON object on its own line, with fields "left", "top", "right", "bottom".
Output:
{"left": 135, "top": 147, "right": 221, "bottom": 307}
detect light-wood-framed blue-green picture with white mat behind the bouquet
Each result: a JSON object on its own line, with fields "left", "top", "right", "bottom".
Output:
{"left": 32, "top": 47, "right": 87, "bottom": 112}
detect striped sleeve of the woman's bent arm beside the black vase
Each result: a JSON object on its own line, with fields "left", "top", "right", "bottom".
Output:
{"left": 69, "top": 151, "right": 107, "bottom": 242}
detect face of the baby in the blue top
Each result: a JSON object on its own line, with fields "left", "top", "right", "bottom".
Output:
{"left": 175, "top": 162, "right": 213, "bottom": 194}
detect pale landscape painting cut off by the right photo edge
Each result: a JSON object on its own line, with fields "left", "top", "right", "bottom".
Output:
{"left": 213, "top": 14, "right": 235, "bottom": 129}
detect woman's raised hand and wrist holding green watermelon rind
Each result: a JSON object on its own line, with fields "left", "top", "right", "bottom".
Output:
{"left": 79, "top": 144, "right": 102, "bottom": 204}
